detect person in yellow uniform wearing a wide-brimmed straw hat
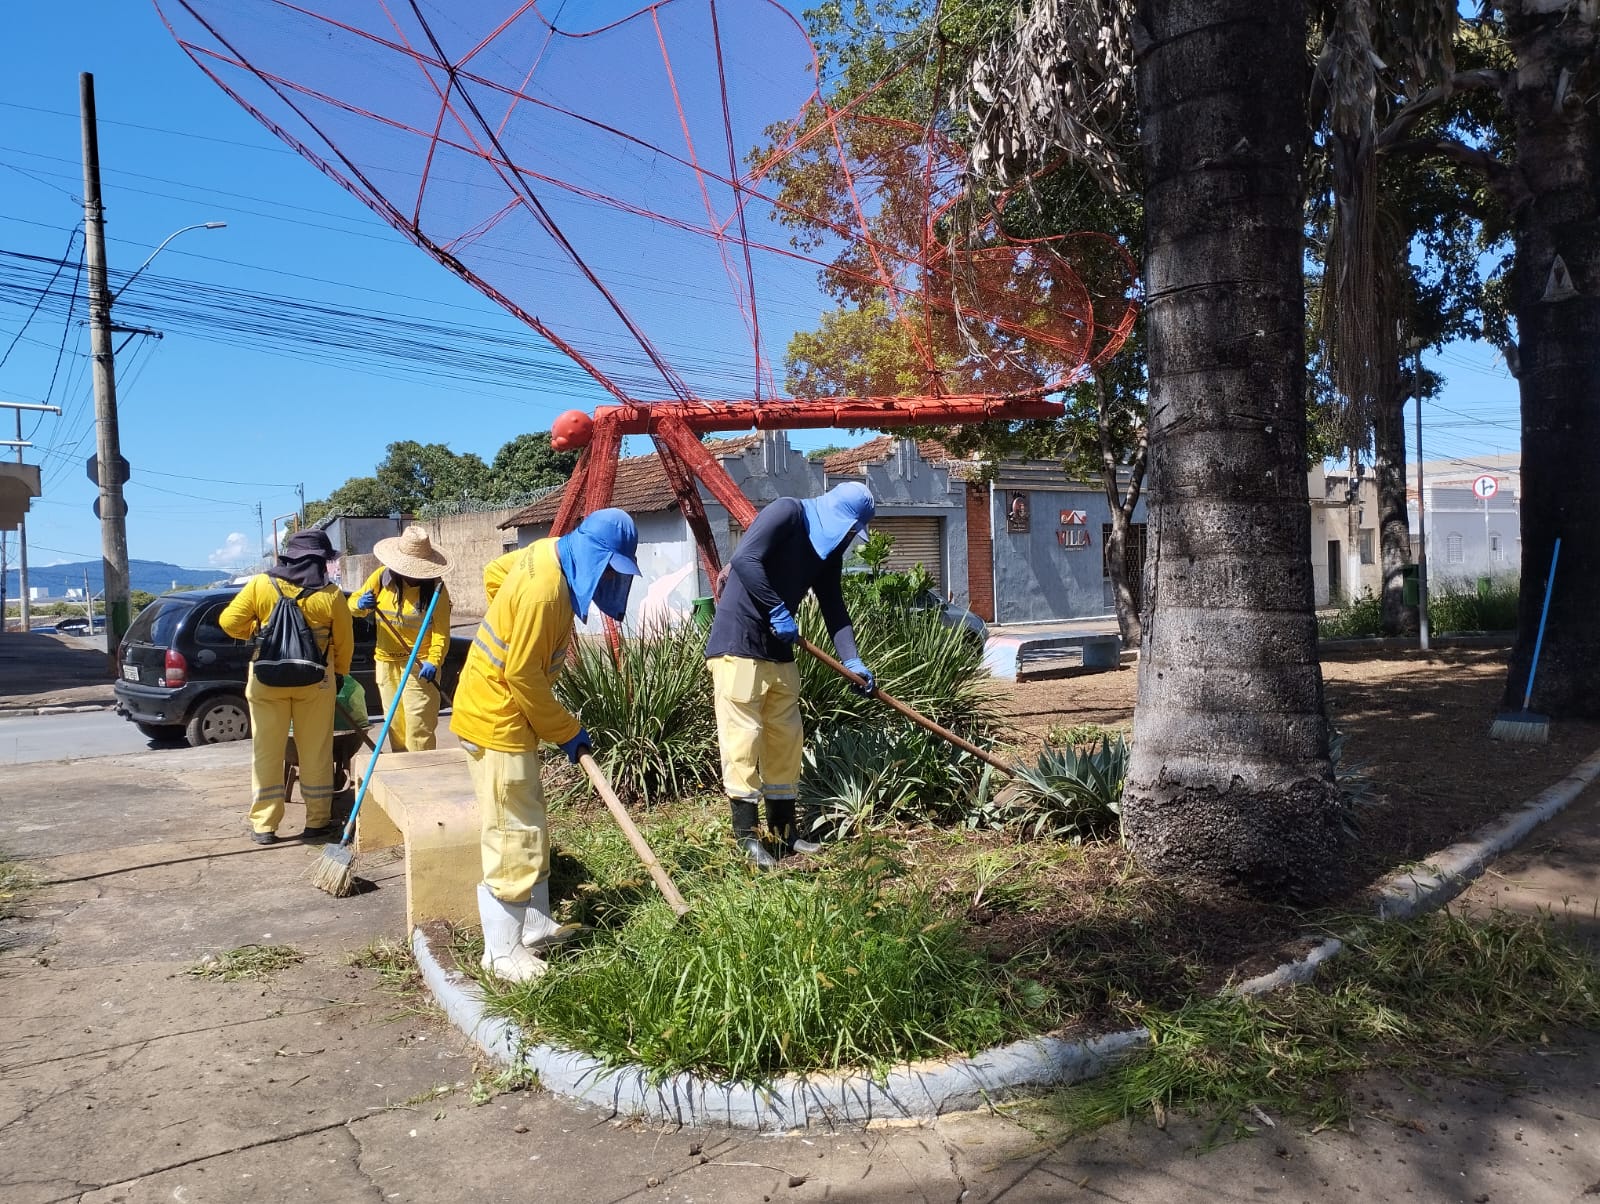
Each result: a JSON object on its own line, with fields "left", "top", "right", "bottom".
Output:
{"left": 350, "top": 527, "right": 450, "bottom": 753}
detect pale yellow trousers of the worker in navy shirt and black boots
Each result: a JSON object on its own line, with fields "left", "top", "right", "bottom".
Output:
{"left": 706, "top": 656, "right": 805, "bottom": 801}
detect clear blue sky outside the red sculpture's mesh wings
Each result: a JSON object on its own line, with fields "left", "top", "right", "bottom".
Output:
{"left": 0, "top": 0, "right": 1517, "bottom": 567}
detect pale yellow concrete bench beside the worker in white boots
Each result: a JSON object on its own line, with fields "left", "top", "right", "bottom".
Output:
{"left": 355, "top": 748, "right": 483, "bottom": 932}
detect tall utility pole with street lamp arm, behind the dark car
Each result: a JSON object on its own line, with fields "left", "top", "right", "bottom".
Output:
{"left": 78, "top": 72, "right": 131, "bottom": 674}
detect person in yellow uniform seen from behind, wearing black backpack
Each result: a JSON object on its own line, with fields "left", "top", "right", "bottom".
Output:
{"left": 218, "top": 530, "right": 355, "bottom": 844}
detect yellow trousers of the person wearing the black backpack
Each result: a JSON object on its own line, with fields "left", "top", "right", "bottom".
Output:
{"left": 245, "top": 668, "right": 334, "bottom": 833}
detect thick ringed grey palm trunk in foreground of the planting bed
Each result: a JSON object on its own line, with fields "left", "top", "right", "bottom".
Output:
{"left": 1122, "top": 0, "right": 1344, "bottom": 898}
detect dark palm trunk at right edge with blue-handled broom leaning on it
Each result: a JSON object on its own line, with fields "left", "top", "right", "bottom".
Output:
{"left": 1504, "top": 0, "right": 1600, "bottom": 717}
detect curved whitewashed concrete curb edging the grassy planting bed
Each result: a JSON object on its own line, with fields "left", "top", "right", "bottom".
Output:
{"left": 411, "top": 749, "right": 1600, "bottom": 1132}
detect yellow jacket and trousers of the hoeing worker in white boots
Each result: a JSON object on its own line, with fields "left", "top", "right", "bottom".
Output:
{"left": 450, "top": 540, "right": 581, "bottom": 903}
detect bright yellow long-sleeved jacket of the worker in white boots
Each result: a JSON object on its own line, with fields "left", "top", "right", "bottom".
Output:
{"left": 450, "top": 540, "right": 579, "bottom": 753}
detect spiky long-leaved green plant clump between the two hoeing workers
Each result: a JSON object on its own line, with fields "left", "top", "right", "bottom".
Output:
{"left": 555, "top": 623, "right": 717, "bottom": 804}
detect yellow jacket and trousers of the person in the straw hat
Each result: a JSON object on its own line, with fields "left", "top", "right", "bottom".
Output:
{"left": 350, "top": 568, "right": 450, "bottom": 753}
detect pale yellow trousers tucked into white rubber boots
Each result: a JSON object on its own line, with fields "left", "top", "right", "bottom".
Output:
{"left": 461, "top": 740, "right": 550, "bottom": 903}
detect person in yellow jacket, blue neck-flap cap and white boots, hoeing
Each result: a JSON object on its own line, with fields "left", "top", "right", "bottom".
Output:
{"left": 450, "top": 509, "right": 638, "bottom": 981}
